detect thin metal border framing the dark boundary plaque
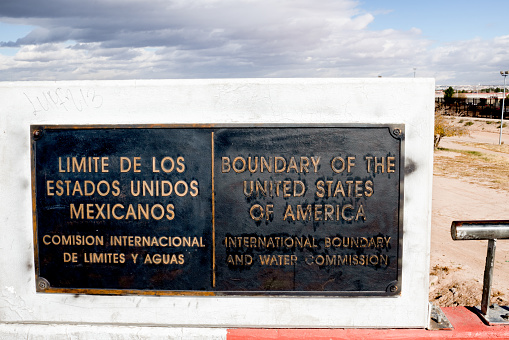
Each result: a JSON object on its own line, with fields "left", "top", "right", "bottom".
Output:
{"left": 30, "top": 123, "right": 405, "bottom": 297}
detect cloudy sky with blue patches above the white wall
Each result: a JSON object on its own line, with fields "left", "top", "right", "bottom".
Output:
{"left": 0, "top": 0, "right": 509, "bottom": 85}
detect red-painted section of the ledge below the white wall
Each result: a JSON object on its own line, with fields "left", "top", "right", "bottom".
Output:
{"left": 227, "top": 307, "right": 509, "bottom": 340}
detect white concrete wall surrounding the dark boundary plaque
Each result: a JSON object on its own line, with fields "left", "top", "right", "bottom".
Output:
{"left": 0, "top": 78, "right": 434, "bottom": 339}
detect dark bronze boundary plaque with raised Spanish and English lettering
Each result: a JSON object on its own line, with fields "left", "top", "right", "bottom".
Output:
{"left": 31, "top": 125, "right": 404, "bottom": 295}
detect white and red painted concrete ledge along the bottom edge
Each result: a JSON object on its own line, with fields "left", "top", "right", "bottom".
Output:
{"left": 0, "top": 307, "right": 509, "bottom": 340}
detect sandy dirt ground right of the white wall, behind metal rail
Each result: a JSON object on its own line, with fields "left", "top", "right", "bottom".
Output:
{"left": 429, "top": 117, "right": 509, "bottom": 307}
